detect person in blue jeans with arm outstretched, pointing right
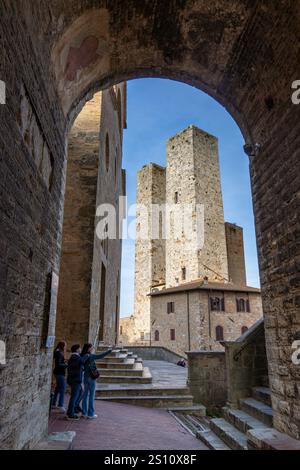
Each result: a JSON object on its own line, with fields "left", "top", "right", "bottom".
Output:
{"left": 81, "top": 343, "right": 112, "bottom": 419}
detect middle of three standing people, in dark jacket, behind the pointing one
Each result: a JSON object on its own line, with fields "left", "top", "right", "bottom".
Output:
{"left": 67, "top": 344, "right": 87, "bottom": 420}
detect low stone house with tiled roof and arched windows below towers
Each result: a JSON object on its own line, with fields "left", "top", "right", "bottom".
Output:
{"left": 151, "top": 282, "right": 262, "bottom": 356}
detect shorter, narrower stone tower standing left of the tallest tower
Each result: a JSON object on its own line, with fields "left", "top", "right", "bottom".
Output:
{"left": 132, "top": 163, "right": 166, "bottom": 344}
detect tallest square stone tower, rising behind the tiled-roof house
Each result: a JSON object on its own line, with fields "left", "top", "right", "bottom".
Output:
{"left": 166, "top": 126, "right": 228, "bottom": 288}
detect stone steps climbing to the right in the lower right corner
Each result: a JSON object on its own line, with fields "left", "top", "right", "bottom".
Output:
{"left": 197, "top": 387, "right": 273, "bottom": 450}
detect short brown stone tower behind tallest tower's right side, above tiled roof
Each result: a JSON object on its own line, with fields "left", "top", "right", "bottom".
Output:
{"left": 225, "top": 222, "right": 247, "bottom": 286}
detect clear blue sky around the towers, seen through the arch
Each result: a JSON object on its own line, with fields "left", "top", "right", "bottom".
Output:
{"left": 120, "top": 78, "right": 259, "bottom": 316}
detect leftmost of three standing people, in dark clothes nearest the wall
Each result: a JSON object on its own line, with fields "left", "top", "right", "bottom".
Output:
{"left": 52, "top": 341, "right": 68, "bottom": 413}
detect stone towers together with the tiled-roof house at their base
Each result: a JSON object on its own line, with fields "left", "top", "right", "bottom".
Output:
{"left": 120, "top": 126, "right": 262, "bottom": 354}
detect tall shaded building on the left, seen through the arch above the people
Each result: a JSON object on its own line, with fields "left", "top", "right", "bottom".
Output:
{"left": 56, "top": 83, "right": 126, "bottom": 348}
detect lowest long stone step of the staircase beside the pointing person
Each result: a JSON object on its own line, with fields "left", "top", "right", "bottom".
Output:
{"left": 96, "top": 395, "right": 193, "bottom": 409}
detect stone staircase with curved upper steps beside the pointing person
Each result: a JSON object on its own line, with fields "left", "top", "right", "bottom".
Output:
{"left": 96, "top": 346, "right": 205, "bottom": 416}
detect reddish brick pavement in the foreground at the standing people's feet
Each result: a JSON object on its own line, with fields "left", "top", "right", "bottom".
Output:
{"left": 49, "top": 400, "right": 207, "bottom": 450}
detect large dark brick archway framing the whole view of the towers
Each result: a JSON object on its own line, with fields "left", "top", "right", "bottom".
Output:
{"left": 0, "top": 0, "right": 300, "bottom": 448}
